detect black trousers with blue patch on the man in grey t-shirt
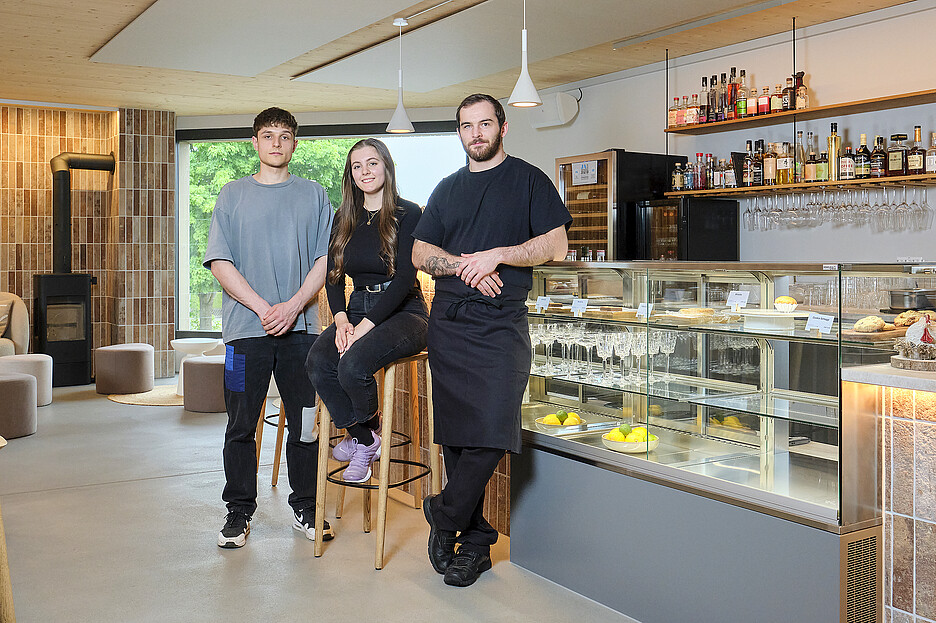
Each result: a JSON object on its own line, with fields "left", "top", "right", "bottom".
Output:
{"left": 222, "top": 331, "right": 318, "bottom": 516}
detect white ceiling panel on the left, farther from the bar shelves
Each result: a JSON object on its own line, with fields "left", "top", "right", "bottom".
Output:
{"left": 91, "top": 0, "right": 413, "bottom": 76}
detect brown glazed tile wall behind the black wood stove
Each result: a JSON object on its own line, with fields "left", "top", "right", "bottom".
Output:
{"left": 0, "top": 105, "right": 175, "bottom": 376}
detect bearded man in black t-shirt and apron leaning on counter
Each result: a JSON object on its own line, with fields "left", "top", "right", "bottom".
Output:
{"left": 413, "top": 94, "right": 572, "bottom": 586}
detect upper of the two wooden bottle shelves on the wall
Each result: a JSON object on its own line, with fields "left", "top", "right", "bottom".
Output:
{"left": 664, "top": 89, "right": 936, "bottom": 134}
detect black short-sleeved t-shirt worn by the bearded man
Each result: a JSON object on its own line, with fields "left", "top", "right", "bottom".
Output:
{"left": 413, "top": 156, "right": 572, "bottom": 300}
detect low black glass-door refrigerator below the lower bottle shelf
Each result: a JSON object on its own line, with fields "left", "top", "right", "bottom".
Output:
{"left": 632, "top": 197, "right": 738, "bottom": 261}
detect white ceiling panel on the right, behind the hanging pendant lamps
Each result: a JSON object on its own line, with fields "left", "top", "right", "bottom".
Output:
{"left": 297, "top": 0, "right": 751, "bottom": 93}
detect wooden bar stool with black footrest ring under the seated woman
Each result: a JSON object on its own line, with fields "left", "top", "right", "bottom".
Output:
{"left": 314, "top": 352, "right": 442, "bottom": 569}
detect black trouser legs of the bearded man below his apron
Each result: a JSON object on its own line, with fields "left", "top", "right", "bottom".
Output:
{"left": 429, "top": 446, "right": 505, "bottom": 554}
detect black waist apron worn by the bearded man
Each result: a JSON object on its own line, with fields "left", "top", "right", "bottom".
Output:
{"left": 429, "top": 291, "right": 533, "bottom": 453}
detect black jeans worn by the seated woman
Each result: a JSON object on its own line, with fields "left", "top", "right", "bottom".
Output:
{"left": 306, "top": 290, "right": 429, "bottom": 428}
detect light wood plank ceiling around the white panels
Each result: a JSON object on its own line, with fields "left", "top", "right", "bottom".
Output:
{"left": 0, "top": 0, "right": 910, "bottom": 115}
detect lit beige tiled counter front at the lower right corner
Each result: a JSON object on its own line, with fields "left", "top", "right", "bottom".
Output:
{"left": 882, "top": 388, "right": 936, "bottom": 623}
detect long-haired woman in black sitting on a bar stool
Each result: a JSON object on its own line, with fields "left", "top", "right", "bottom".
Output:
{"left": 306, "top": 138, "right": 428, "bottom": 482}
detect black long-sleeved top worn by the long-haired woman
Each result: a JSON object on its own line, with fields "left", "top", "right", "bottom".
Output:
{"left": 325, "top": 199, "right": 422, "bottom": 325}
